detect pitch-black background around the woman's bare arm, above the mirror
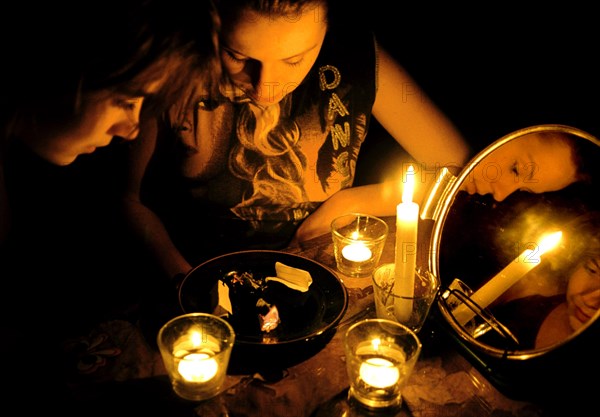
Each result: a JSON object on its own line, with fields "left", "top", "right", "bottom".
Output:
{"left": 357, "top": 4, "right": 600, "bottom": 183}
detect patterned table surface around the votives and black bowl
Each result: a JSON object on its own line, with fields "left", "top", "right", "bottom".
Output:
{"left": 58, "top": 219, "right": 544, "bottom": 417}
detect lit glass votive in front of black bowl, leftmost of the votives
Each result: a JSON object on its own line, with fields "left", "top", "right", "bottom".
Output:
{"left": 157, "top": 313, "right": 235, "bottom": 401}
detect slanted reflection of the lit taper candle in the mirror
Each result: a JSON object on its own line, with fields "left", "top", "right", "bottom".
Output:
{"left": 452, "top": 232, "right": 562, "bottom": 325}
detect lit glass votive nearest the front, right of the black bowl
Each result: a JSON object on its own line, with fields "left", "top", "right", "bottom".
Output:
{"left": 344, "top": 318, "right": 422, "bottom": 409}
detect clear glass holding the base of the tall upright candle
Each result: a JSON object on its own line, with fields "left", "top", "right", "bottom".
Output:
{"left": 373, "top": 263, "right": 439, "bottom": 332}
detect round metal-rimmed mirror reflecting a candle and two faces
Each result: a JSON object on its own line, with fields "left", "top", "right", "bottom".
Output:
{"left": 432, "top": 125, "right": 600, "bottom": 351}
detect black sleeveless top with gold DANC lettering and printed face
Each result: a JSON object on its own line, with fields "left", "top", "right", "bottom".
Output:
{"left": 142, "top": 26, "right": 376, "bottom": 263}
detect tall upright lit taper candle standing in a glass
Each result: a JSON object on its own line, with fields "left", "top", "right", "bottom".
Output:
{"left": 394, "top": 165, "right": 419, "bottom": 322}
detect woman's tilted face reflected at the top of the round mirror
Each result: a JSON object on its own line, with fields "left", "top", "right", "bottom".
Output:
{"left": 461, "top": 132, "right": 577, "bottom": 201}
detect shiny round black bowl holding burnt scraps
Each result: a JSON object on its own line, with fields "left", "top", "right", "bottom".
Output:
{"left": 179, "top": 250, "right": 348, "bottom": 373}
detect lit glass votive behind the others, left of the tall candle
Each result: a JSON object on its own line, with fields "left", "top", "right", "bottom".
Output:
{"left": 331, "top": 213, "right": 388, "bottom": 277}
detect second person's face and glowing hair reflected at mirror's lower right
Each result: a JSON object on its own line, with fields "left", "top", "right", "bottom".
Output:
{"left": 492, "top": 211, "right": 600, "bottom": 349}
